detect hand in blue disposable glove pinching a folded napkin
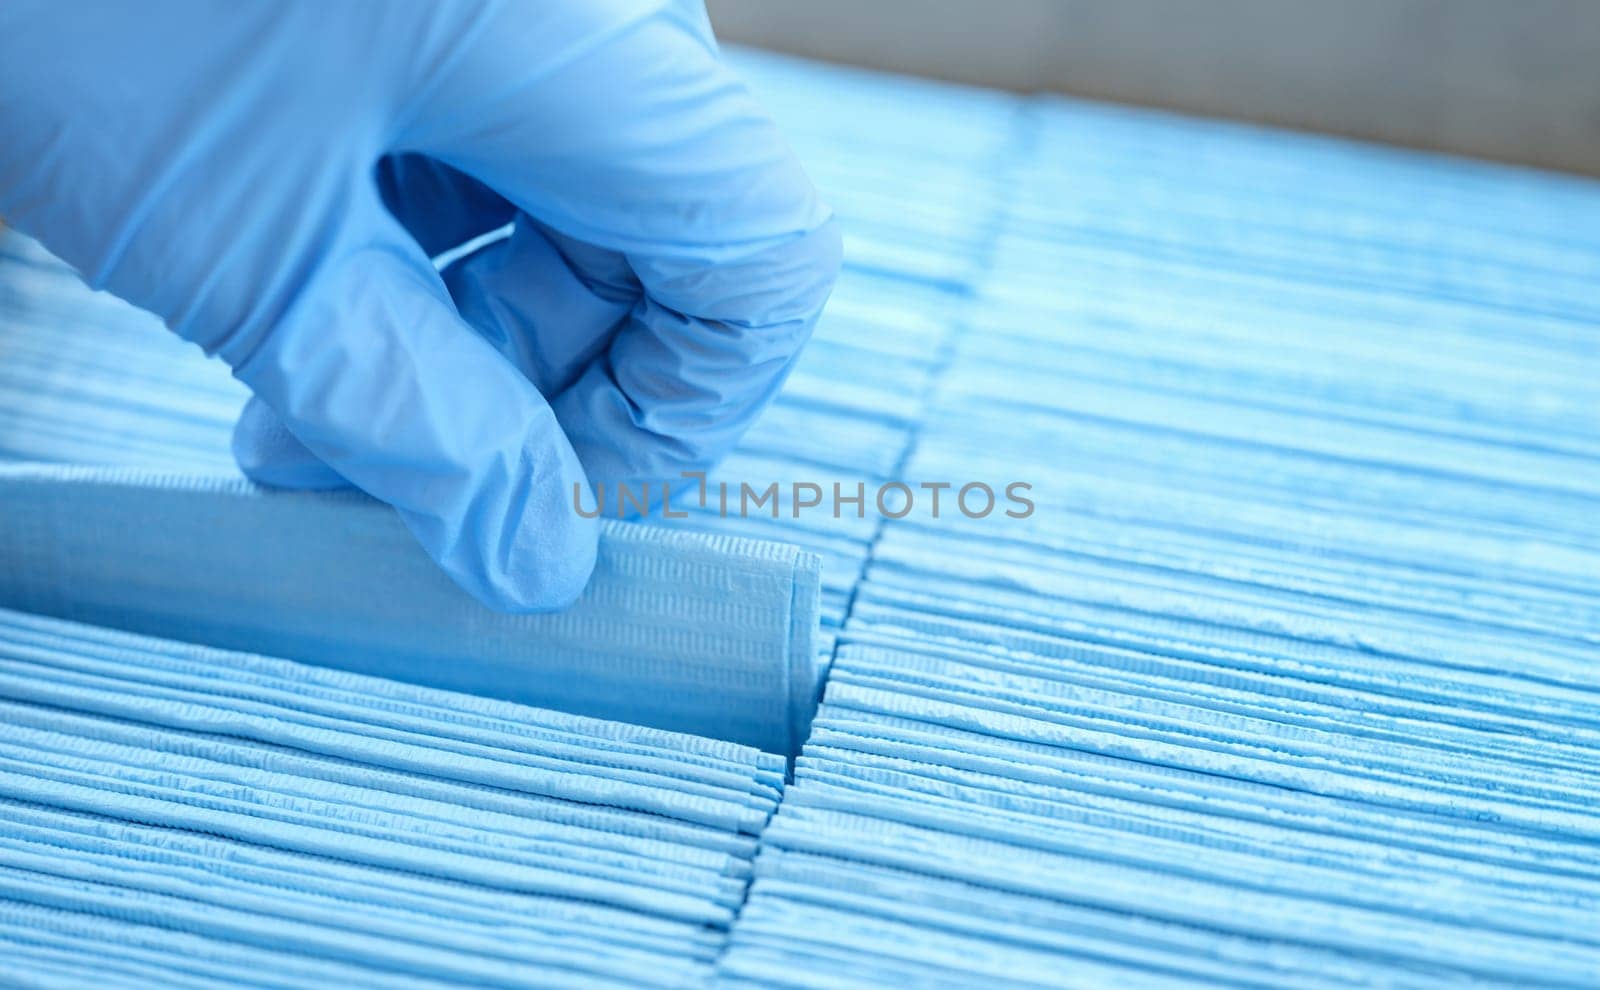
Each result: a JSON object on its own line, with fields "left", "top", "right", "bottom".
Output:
{"left": 0, "top": 0, "right": 840, "bottom": 611}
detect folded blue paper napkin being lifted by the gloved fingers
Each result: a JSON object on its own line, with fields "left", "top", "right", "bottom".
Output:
{"left": 0, "top": 464, "right": 819, "bottom": 753}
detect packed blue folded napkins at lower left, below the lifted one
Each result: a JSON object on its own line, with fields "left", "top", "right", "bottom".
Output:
{"left": 0, "top": 609, "right": 784, "bottom": 987}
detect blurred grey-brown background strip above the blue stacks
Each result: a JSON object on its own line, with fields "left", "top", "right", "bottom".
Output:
{"left": 707, "top": 0, "right": 1600, "bottom": 176}
